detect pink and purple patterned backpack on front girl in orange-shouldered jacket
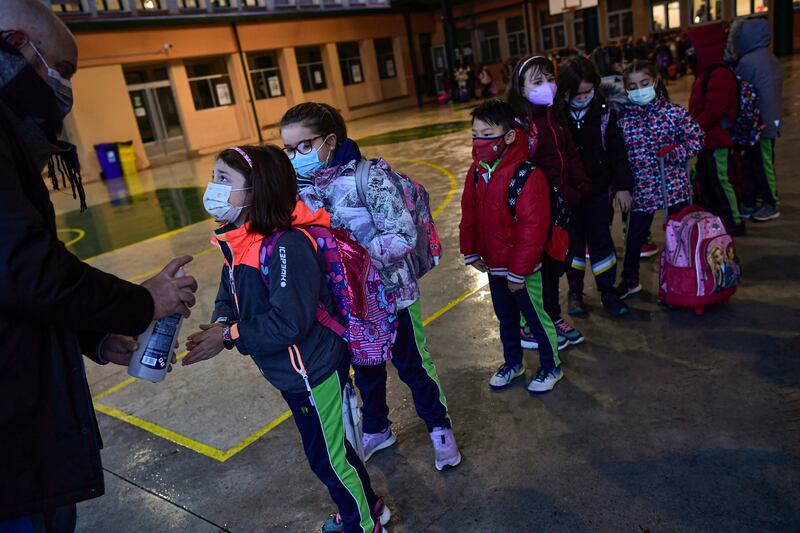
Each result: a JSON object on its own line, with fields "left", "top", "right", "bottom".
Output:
{"left": 259, "top": 226, "right": 397, "bottom": 366}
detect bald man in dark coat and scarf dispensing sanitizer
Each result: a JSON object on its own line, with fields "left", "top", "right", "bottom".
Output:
{"left": 0, "top": 0, "right": 197, "bottom": 532}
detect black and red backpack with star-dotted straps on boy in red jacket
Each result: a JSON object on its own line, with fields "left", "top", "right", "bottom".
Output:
{"left": 473, "top": 161, "right": 570, "bottom": 263}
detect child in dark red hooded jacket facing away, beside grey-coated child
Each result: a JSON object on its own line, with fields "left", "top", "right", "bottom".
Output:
{"left": 689, "top": 24, "right": 745, "bottom": 235}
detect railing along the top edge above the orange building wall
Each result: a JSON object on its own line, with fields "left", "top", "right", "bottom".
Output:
{"left": 44, "top": 0, "right": 391, "bottom": 20}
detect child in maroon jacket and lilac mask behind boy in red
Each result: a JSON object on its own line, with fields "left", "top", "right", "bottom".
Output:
{"left": 508, "top": 56, "right": 592, "bottom": 348}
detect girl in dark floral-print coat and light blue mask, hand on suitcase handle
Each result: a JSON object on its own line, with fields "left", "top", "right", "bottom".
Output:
{"left": 617, "top": 61, "right": 703, "bottom": 298}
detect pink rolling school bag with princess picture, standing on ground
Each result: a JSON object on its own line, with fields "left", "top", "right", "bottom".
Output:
{"left": 658, "top": 205, "right": 742, "bottom": 315}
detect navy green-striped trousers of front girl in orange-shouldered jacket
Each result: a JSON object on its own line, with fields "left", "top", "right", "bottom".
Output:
{"left": 282, "top": 358, "right": 378, "bottom": 533}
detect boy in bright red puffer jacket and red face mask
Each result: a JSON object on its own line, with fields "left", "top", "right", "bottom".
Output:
{"left": 459, "top": 100, "right": 564, "bottom": 394}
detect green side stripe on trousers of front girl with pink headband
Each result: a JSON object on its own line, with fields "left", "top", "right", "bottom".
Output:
{"left": 311, "top": 372, "right": 375, "bottom": 533}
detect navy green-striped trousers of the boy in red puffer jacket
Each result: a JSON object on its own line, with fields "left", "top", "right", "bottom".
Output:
{"left": 489, "top": 271, "right": 561, "bottom": 370}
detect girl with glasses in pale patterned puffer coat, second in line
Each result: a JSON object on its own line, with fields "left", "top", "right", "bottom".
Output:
{"left": 280, "top": 102, "right": 461, "bottom": 470}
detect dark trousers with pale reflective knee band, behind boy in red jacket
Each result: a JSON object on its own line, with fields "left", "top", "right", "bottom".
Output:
{"left": 567, "top": 194, "right": 617, "bottom": 294}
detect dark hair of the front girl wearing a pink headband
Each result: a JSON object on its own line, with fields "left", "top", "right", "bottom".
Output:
{"left": 217, "top": 144, "right": 297, "bottom": 235}
